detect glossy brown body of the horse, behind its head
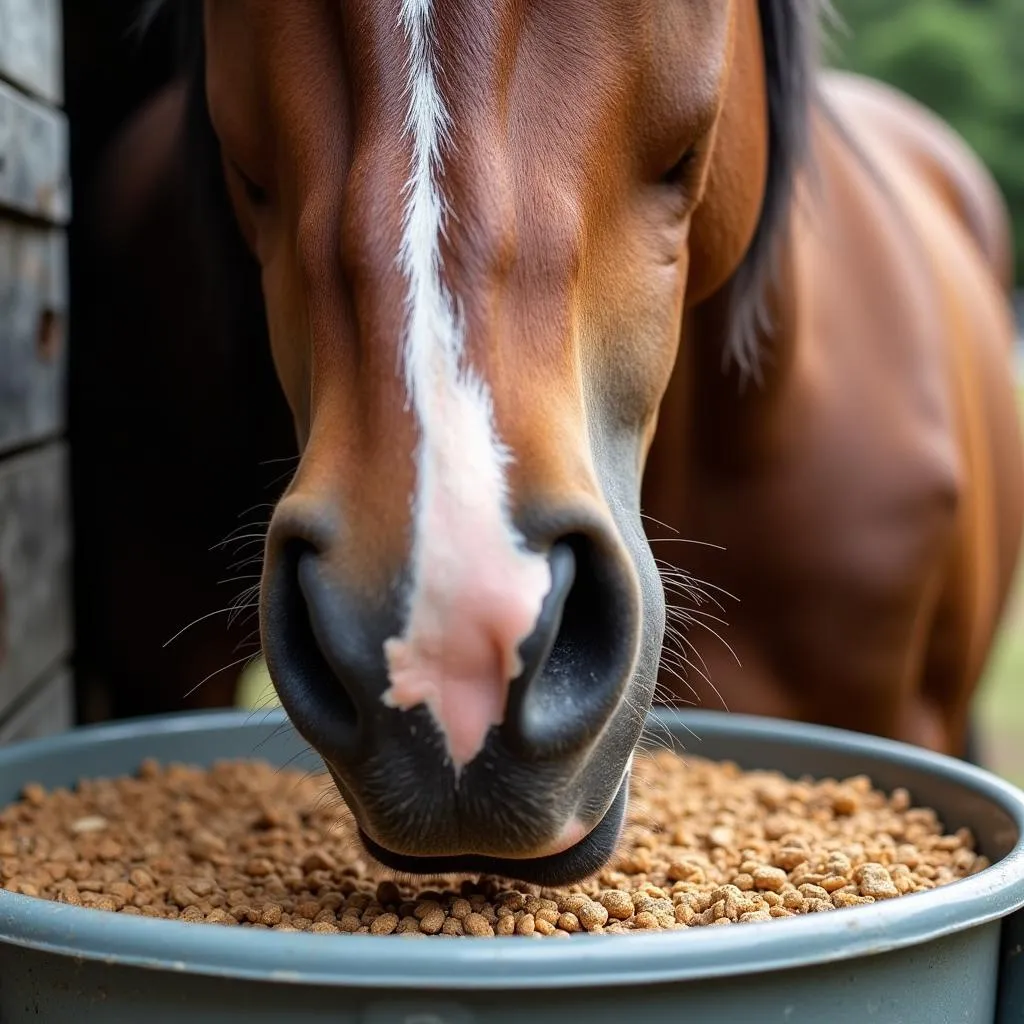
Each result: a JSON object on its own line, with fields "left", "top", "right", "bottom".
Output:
{"left": 644, "top": 75, "right": 1022, "bottom": 755}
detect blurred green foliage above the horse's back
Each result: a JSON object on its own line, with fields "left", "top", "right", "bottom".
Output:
{"left": 827, "top": 0, "right": 1024, "bottom": 287}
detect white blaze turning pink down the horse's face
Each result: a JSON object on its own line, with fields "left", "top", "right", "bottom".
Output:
{"left": 384, "top": 0, "right": 551, "bottom": 771}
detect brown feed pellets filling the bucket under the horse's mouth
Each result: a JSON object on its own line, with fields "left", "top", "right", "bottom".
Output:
{"left": 0, "top": 753, "right": 988, "bottom": 938}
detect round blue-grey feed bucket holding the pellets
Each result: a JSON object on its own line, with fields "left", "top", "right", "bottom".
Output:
{"left": 0, "top": 712, "right": 1024, "bottom": 1024}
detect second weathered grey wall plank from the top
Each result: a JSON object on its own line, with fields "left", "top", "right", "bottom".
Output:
{"left": 0, "top": 82, "right": 71, "bottom": 224}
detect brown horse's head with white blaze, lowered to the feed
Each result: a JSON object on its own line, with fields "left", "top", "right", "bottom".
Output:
{"left": 186, "top": 0, "right": 812, "bottom": 883}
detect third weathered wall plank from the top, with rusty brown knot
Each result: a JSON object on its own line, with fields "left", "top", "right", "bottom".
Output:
{"left": 0, "top": 220, "right": 68, "bottom": 455}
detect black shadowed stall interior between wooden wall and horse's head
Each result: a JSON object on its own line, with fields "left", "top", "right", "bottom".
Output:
{"left": 65, "top": 0, "right": 295, "bottom": 722}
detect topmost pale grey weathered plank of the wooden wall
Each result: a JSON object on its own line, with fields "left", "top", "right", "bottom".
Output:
{"left": 0, "top": 0, "right": 63, "bottom": 103}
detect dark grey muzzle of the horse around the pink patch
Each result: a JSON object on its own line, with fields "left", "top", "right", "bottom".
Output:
{"left": 261, "top": 500, "right": 642, "bottom": 885}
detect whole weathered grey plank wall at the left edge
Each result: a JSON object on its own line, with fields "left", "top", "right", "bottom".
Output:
{"left": 0, "top": 0, "right": 74, "bottom": 742}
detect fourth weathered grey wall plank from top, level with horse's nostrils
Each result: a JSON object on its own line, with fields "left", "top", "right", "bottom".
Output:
{"left": 0, "top": 441, "right": 73, "bottom": 709}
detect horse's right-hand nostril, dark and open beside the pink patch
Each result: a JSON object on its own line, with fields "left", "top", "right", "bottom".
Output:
{"left": 503, "top": 535, "right": 636, "bottom": 759}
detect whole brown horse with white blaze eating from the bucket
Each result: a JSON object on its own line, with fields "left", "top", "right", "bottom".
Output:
{"left": 132, "top": 0, "right": 1024, "bottom": 884}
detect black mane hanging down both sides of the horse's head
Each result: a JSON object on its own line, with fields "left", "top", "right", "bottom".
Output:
{"left": 139, "top": 0, "right": 827, "bottom": 376}
